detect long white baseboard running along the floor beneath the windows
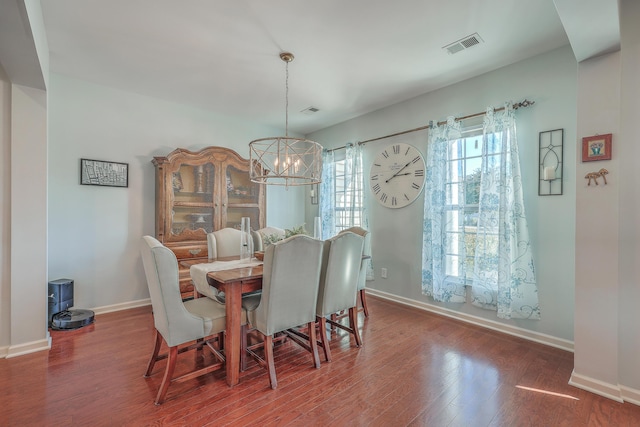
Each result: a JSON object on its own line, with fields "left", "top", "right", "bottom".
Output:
{"left": 367, "top": 288, "right": 573, "bottom": 352}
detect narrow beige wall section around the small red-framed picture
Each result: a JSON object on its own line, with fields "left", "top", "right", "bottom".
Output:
{"left": 573, "top": 53, "right": 620, "bottom": 400}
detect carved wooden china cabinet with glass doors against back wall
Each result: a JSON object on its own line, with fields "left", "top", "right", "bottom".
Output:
{"left": 153, "top": 147, "right": 266, "bottom": 298}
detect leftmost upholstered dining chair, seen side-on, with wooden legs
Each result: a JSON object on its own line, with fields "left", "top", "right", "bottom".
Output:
{"left": 140, "top": 236, "right": 231, "bottom": 405}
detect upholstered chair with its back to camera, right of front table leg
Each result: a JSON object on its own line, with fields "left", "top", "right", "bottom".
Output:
{"left": 246, "top": 235, "right": 323, "bottom": 389}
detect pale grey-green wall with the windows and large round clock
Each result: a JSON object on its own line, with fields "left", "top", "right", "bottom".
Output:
{"left": 307, "top": 46, "right": 577, "bottom": 348}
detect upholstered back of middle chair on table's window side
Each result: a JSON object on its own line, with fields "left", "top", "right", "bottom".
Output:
{"left": 316, "top": 232, "right": 364, "bottom": 317}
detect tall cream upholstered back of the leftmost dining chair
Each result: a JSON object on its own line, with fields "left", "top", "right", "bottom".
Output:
{"left": 140, "top": 236, "right": 205, "bottom": 347}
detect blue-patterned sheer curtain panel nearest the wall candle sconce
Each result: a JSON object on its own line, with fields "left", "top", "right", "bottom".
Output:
{"left": 471, "top": 104, "right": 540, "bottom": 319}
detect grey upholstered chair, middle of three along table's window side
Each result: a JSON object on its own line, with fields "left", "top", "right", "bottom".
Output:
{"left": 316, "top": 232, "right": 364, "bottom": 362}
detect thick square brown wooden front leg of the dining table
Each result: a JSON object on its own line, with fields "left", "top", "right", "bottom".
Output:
{"left": 225, "top": 284, "right": 242, "bottom": 387}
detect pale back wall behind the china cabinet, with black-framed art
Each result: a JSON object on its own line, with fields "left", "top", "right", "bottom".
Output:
{"left": 49, "top": 74, "right": 304, "bottom": 311}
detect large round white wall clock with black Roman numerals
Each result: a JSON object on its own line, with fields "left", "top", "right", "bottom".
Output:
{"left": 369, "top": 143, "right": 425, "bottom": 209}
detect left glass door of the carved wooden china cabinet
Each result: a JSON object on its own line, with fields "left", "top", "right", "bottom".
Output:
{"left": 169, "top": 163, "right": 216, "bottom": 235}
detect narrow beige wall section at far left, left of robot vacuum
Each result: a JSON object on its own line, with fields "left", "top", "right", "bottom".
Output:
{"left": 7, "top": 85, "right": 50, "bottom": 357}
